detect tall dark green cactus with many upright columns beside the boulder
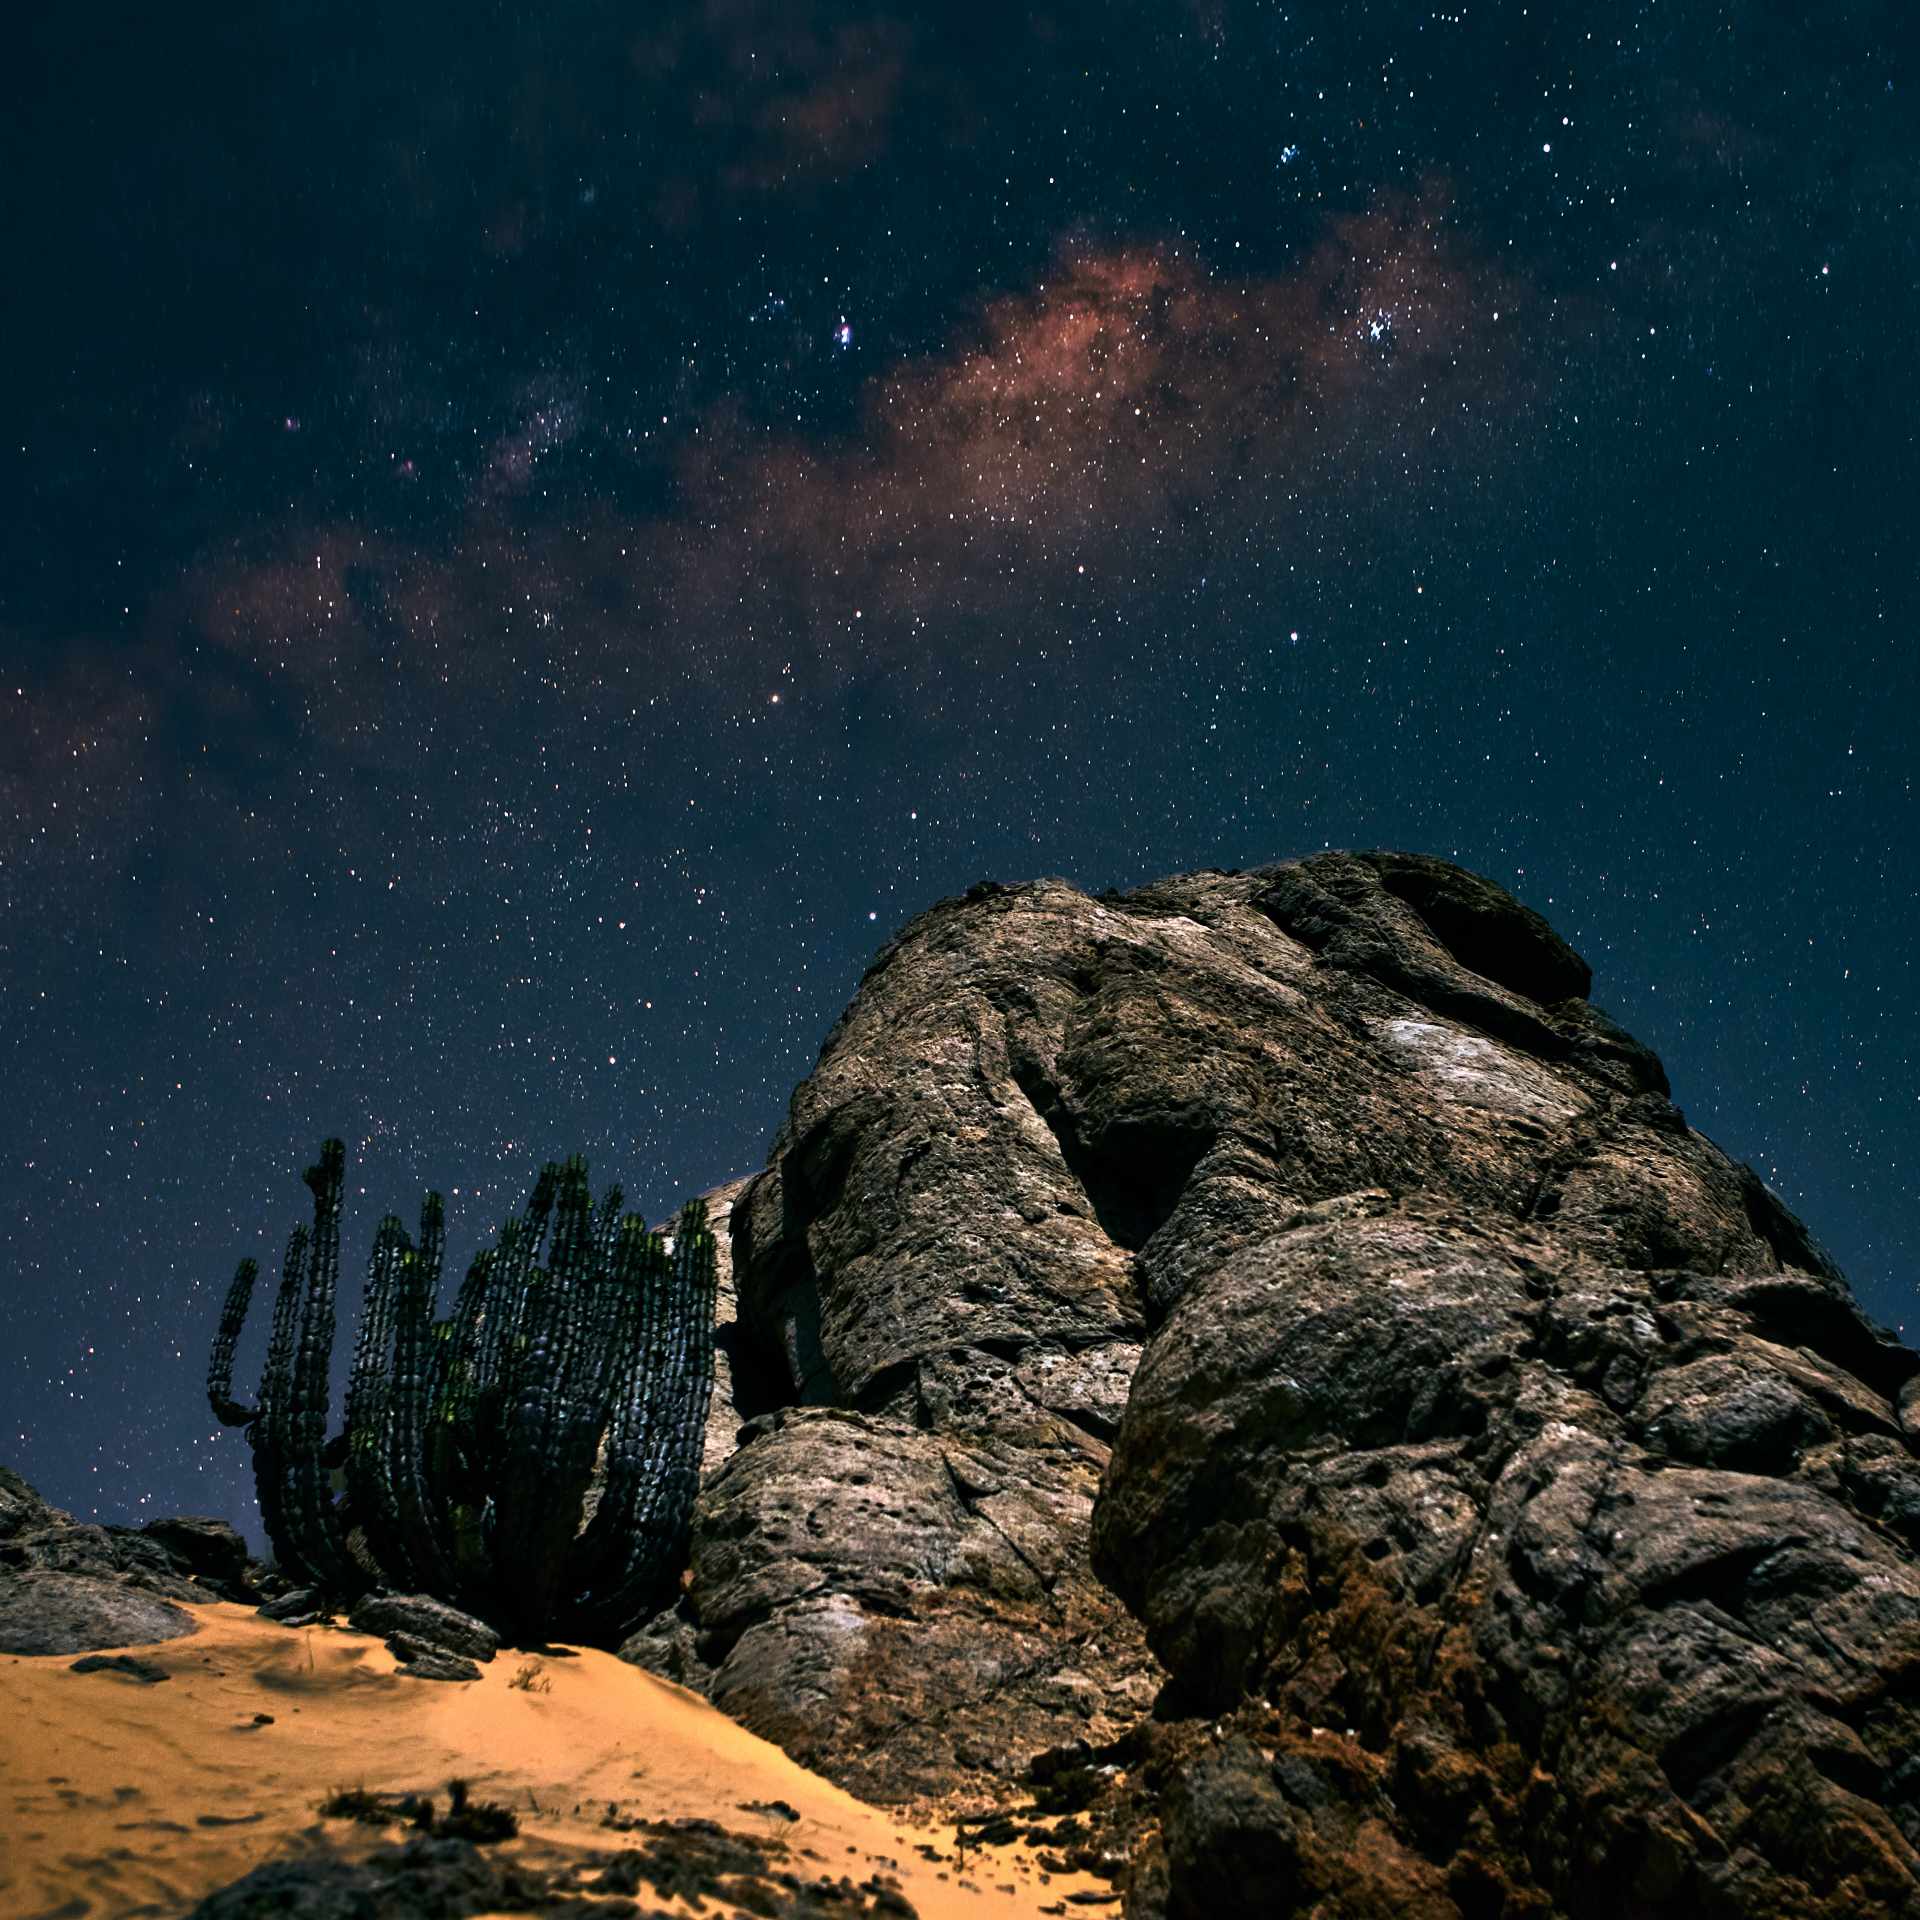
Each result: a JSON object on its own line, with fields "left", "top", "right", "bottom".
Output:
{"left": 207, "top": 1140, "right": 714, "bottom": 1640}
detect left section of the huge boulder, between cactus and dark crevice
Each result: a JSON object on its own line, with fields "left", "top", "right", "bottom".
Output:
{"left": 624, "top": 885, "right": 1164, "bottom": 1799}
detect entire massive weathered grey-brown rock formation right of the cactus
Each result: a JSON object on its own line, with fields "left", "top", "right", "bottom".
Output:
{"left": 632, "top": 854, "right": 1920, "bottom": 1920}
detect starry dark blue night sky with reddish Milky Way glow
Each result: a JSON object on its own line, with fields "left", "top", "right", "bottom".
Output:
{"left": 0, "top": 0, "right": 1920, "bottom": 1538}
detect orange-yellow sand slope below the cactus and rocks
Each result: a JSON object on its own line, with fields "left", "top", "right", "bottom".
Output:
{"left": 0, "top": 1605, "right": 1116, "bottom": 1920}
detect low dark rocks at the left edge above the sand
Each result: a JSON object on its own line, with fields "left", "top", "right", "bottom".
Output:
{"left": 0, "top": 1467, "right": 263, "bottom": 1653}
